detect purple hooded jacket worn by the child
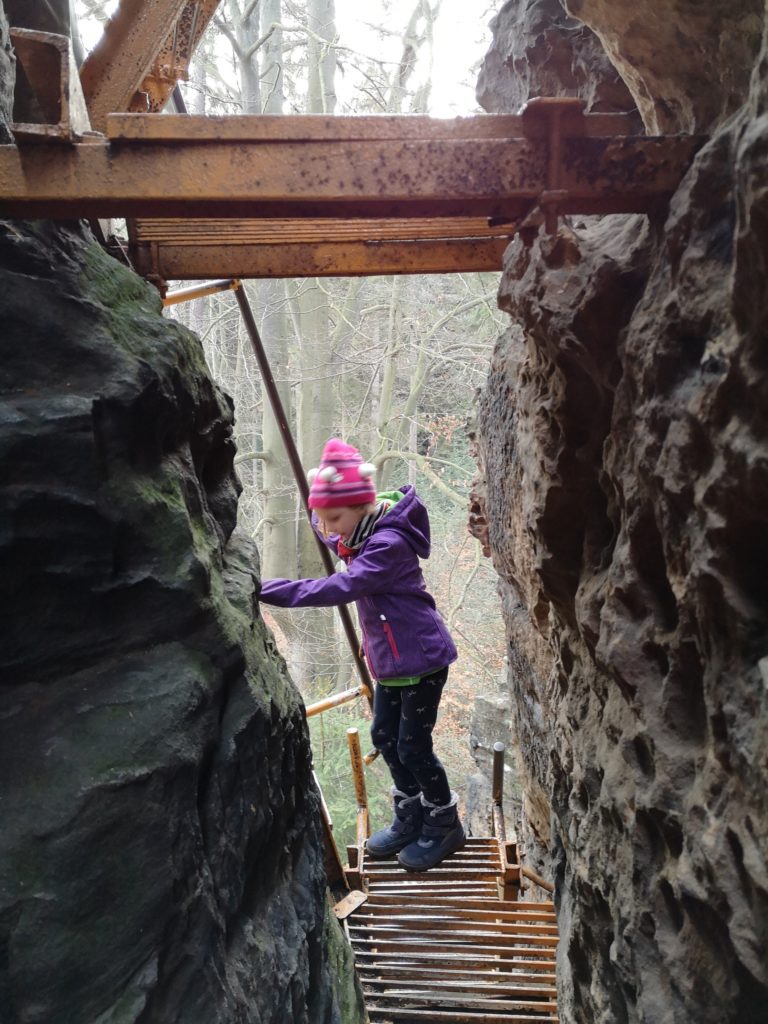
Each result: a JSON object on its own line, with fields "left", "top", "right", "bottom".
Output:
{"left": 261, "top": 485, "right": 457, "bottom": 679}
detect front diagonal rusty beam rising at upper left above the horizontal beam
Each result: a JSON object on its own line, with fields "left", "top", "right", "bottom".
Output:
{"left": 80, "top": 0, "right": 187, "bottom": 131}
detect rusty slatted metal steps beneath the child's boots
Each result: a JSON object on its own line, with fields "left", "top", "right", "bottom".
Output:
{"left": 337, "top": 838, "right": 558, "bottom": 1024}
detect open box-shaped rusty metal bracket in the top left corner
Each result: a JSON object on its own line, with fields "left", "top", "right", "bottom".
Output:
{"left": 10, "top": 29, "right": 92, "bottom": 142}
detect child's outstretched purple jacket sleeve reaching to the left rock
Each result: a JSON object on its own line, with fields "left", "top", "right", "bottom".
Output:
{"left": 260, "top": 531, "right": 406, "bottom": 608}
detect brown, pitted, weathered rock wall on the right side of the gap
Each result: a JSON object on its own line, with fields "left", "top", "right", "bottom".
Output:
{"left": 475, "top": 0, "right": 768, "bottom": 1024}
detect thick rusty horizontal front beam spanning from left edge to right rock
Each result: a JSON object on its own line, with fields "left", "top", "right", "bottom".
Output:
{"left": 0, "top": 130, "right": 702, "bottom": 220}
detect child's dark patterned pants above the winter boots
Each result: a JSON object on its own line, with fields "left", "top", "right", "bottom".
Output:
{"left": 371, "top": 668, "right": 451, "bottom": 804}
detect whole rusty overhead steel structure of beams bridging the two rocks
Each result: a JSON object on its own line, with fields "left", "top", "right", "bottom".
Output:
{"left": 0, "top": 0, "right": 702, "bottom": 288}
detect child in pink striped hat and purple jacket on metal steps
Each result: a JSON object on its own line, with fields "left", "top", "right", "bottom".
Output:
{"left": 261, "top": 438, "right": 465, "bottom": 871}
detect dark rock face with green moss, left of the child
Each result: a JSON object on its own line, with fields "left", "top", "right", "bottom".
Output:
{"left": 0, "top": 222, "right": 361, "bottom": 1024}
